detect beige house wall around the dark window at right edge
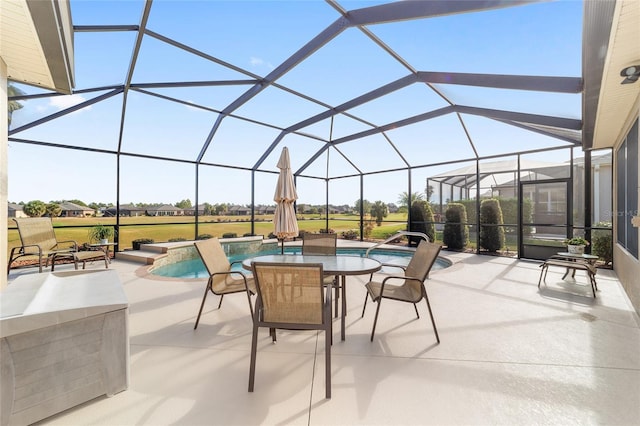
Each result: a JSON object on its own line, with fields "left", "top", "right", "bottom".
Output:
{"left": 613, "top": 96, "right": 640, "bottom": 314}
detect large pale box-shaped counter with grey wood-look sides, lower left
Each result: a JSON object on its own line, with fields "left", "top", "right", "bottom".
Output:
{"left": 0, "top": 270, "right": 129, "bottom": 426}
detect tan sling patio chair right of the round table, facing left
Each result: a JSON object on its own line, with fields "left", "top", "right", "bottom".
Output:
{"left": 362, "top": 240, "right": 442, "bottom": 343}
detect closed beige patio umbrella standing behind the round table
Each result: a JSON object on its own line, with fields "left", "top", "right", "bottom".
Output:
{"left": 273, "top": 146, "right": 298, "bottom": 253}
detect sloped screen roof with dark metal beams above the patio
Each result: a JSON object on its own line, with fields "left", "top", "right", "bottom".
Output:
{"left": 9, "top": 0, "right": 582, "bottom": 203}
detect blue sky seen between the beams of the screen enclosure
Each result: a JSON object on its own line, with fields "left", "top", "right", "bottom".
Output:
{"left": 8, "top": 0, "right": 582, "bottom": 208}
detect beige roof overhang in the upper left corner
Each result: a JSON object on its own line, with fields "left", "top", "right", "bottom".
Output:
{"left": 0, "top": 0, "right": 75, "bottom": 94}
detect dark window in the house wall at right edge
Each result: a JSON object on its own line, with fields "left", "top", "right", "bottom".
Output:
{"left": 616, "top": 120, "right": 639, "bottom": 259}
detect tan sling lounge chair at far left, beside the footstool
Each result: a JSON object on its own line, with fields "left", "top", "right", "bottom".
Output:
{"left": 7, "top": 217, "right": 78, "bottom": 274}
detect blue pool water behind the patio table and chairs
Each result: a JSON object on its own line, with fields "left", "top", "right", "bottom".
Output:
{"left": 151, "top": 247, "right": 449, "bottom": 278}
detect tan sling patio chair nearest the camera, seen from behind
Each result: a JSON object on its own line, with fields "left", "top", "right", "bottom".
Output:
{"left": 249, "top": 262, "right": 332, "bottom": 398}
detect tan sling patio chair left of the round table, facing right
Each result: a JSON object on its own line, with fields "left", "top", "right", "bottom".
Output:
{"left": 193, "top": 238, "right": 255, "bottom": 330}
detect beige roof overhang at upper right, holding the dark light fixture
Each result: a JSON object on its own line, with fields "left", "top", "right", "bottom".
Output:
{"left": 582, "top": 0, "right": 640, "bottom": 150}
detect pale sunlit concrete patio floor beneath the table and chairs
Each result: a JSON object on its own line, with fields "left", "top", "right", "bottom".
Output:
{"left": 9, "top": 248, "right": 640, "bottom": 425}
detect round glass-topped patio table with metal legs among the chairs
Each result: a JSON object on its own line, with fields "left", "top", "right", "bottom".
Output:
{"left": 242, "top": 254, "right": 382, "bottom": 340}
